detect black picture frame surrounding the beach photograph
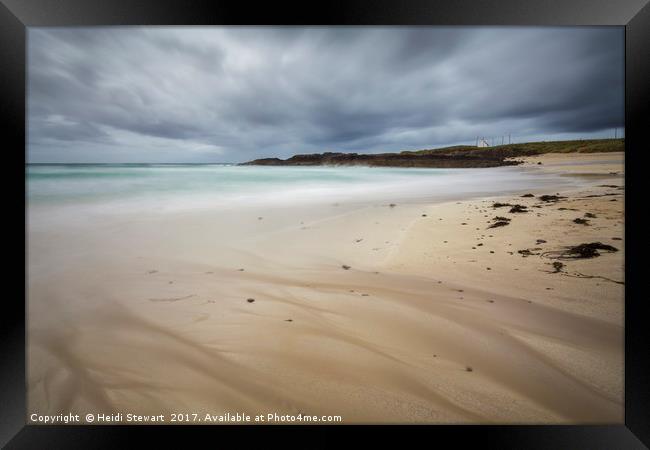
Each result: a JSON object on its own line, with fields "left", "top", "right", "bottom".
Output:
{"left": 0, "top": 0, "right": 650, "bottom": 449}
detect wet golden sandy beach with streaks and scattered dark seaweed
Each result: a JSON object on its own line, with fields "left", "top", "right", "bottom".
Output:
{"left": 27, "top": 153, "right": 625, "bottom": 424}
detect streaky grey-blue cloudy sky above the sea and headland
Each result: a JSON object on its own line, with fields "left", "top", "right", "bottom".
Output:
{"left": 28, "top": 27, "right": 624, "bottom": 162}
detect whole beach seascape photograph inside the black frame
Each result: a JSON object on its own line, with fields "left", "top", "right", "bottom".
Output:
{"left": 25, "top": 26, "right": 632, "bottom": 425}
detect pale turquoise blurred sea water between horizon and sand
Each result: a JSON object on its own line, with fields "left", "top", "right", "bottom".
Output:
{"left": 26, "top": 164, "right": 570, "bottom": 213}
